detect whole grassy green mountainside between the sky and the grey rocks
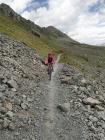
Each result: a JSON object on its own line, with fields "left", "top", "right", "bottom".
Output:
{"left": 0, "top": 4, "right": 105, "bottom": 79}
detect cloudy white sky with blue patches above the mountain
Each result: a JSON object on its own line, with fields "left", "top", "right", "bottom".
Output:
{"left": 0, "top": 0, "right": 105, "bottom": 45}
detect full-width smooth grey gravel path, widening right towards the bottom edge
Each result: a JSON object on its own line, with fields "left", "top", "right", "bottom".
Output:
{"left": 43, "top": 57, "right": 86, "bottom": 140}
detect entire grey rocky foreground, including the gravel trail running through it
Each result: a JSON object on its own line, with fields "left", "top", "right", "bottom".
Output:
{"left": 0, "top": 35, "right": 105, "bottom": 140}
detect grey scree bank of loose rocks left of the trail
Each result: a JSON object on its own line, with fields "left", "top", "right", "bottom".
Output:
{"left": 0, "top": 35, "right": 47, "bottom": 140}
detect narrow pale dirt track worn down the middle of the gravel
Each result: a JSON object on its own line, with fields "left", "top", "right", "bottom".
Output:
{"left": 43, "top": 55, "right": 61, "bottom": 140}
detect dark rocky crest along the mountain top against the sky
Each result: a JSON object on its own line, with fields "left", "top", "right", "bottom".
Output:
{"left": 0, "top": 3, "right": 78, "bottom": 43}
